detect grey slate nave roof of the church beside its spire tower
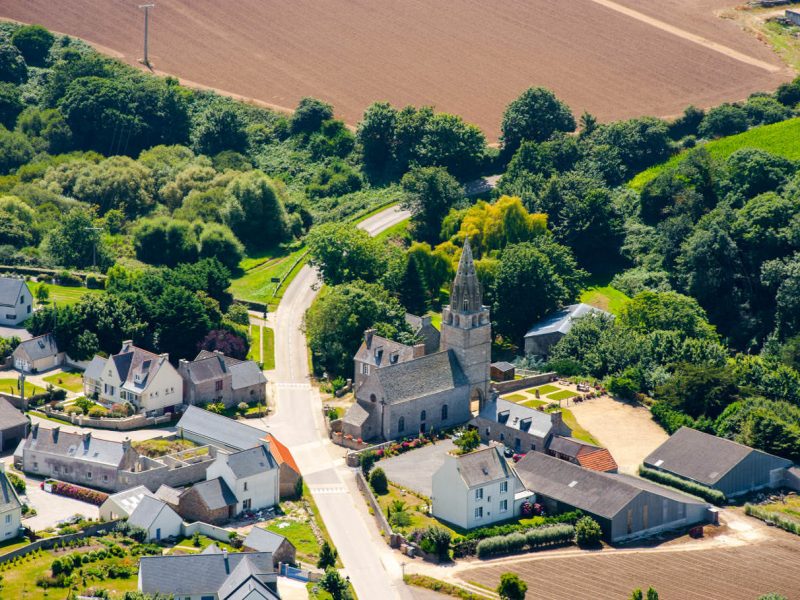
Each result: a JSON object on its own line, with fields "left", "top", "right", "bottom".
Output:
{"left": 375, "top": 350, "right": 469, "bottom": 404}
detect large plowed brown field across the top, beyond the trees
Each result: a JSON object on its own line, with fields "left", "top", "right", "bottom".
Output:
{"left": 0, "top": 0, "right": 791, "bottom": 137}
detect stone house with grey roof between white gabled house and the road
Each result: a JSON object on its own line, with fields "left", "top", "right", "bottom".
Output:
{"left": 178, "top": 350, "right": 267, "bottom": 406}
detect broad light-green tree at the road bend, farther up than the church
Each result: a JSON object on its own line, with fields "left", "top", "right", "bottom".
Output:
{"left": 306, "top": 223, "right": 386, "bottom": 285}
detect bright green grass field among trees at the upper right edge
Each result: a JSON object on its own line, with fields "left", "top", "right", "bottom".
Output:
{"left": 628, "top": 118, "right": 800, "bottom": 191}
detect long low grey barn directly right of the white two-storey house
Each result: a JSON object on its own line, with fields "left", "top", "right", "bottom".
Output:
{"left": 515, "top": 452, "right": 708, "bottom": 542}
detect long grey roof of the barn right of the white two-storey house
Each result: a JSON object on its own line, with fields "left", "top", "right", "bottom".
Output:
{"left": 515, "top": 452, "right": 704, "bottom": 519}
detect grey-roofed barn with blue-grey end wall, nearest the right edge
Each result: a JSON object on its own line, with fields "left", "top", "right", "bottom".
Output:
{"left": 644, "top": 427, "right": 792, "bottom": 497}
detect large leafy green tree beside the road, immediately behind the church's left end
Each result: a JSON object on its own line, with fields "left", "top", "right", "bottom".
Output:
{"left": 305, "top": 281, "right": 409, "bottom": 376}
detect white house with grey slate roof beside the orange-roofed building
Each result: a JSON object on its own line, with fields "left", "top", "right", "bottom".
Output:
{"left": 206, "top": 441, "right": 280, "bottom": 514}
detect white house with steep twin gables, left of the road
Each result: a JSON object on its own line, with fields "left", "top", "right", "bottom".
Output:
{"left": 84, "top": 340, "right": 183, "bottom": 414}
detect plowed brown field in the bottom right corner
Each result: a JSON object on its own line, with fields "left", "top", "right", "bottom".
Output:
{"left": 459, "top": 537, "right": 800, "bottom": 600}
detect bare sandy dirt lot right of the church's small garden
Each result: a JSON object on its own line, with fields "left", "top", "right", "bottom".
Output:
{"left": 569, "top": 396, "right": 669, "bottom": 474}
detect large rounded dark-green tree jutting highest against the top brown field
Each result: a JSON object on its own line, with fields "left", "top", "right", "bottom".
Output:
{"left": 501, "top": 87, "right": 575, "bottom": 158}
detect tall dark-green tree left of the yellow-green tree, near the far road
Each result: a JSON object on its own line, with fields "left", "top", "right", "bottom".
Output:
{"left": 402, "top": 167, "right": 464, "bottom": 243}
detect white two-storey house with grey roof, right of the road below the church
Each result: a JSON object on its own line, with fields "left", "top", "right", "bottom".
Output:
{"left": 431, "top": 446, "right": 533, "bottom": 529}
